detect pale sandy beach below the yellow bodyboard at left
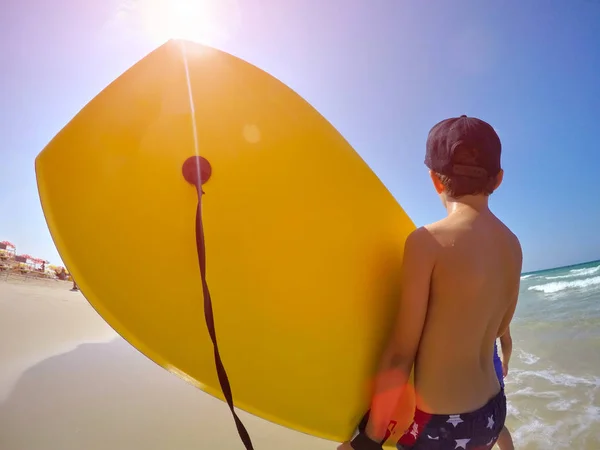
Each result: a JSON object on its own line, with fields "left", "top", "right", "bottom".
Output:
{"left": 0, "top": 278, "right": 335, "bottom": 450}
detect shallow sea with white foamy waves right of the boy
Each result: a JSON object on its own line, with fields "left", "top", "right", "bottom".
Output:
{"left": 505, "top": 261, "right": 600, "bottom": 450}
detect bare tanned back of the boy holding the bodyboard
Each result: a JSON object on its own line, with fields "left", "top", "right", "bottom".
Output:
{"left": 415, "top": 204, "right": 522, "bottom": 414}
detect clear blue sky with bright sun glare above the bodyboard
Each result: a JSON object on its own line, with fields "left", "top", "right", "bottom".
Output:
{"left": 0, "top": 0, "right": 600, "bottom": 270}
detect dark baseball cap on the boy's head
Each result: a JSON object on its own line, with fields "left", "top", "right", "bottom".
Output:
{"left": 425, "top": 115, "right": 502, "bottom": 178}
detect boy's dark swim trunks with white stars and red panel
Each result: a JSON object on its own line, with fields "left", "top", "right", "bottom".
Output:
{"left": 397, "top": 389, "right": 506, "bottom": 450}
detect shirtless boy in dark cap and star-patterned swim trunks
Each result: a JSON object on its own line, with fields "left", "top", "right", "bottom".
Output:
{"left": 338, "top": 116, "right": 522, "bottom": 450}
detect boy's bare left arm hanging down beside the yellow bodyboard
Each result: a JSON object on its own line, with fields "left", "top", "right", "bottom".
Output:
{"left": 366, "top": 228, "right": 437, "bottom": 442}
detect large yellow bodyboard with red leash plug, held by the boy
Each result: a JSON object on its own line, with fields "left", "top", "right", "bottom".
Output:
{"left": 36, "top": 41, "right": 414, "bottom": 441}
